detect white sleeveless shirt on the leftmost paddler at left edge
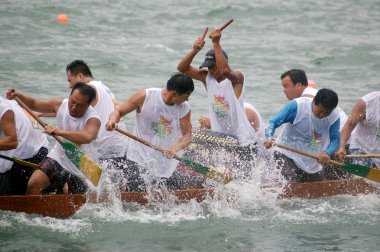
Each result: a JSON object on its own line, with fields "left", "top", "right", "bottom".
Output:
{"left": 3, "top": 100, "right": 49, "bottom": 159}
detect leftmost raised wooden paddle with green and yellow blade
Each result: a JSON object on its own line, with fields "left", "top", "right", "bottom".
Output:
{"left": 15, "top": 97, "right": 102, "bottom": 186}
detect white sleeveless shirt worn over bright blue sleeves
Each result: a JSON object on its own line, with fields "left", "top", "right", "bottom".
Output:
{"left": 276, "top": 97, "right": 339, "bottom": 174}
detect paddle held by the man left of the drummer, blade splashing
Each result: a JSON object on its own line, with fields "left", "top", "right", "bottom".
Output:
{"left": 115, "top": 127, "right": 233, "bottom": 184}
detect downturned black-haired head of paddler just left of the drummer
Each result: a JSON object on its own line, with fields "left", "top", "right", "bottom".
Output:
{"left": 166, "top": 73, "right": 194, "bottom": 105}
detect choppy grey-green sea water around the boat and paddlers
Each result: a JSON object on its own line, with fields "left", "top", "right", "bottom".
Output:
{"left": 0, "top": 0, "right": 380, "bottom": 251}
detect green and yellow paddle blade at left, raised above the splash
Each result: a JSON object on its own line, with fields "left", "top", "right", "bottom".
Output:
{"left": 62, "top": 142, "right": 102, "bottom": 186}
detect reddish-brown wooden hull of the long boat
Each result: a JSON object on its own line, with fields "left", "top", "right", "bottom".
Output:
{"left": 0, "top": 179, "right": 380, "bottom": 218}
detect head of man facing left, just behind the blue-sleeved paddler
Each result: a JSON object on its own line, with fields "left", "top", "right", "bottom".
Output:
{"left": 281, "top": 69, "right": 307, "bottom": 100}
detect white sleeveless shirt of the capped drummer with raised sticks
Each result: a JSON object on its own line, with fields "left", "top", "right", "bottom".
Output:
{"left": 206, "top": 73, "right": 258, "bottom": 146}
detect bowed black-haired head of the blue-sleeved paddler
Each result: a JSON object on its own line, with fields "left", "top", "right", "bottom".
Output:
{"left": 313, "top": 88, "right": 338, "bottom": 119}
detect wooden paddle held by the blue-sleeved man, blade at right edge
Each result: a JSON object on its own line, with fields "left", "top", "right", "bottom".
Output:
{"left": 273, "top": 143, "right": 380, "bottom": 182}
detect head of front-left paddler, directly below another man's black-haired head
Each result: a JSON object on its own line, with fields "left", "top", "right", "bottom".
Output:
{"left": 69, "top": 82, "right": 96, "bottom": 117}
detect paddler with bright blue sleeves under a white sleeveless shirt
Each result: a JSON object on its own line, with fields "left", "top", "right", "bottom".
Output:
{"left": 264, "top": 89, "right": 340, "bottom": 182}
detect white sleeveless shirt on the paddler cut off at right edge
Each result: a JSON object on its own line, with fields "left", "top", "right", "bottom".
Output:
{"left": 350, "top": 91, "right": 380, "bottom": 167}
